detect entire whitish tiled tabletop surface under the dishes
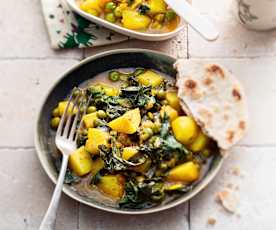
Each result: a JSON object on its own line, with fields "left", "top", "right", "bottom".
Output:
{"left": 0, "top": 0, "right": 276, "bottom": 230}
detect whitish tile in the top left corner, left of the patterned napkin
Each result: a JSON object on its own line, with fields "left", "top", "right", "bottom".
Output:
{"left": 0, "top": 0, "right": 82, "bottom": 58}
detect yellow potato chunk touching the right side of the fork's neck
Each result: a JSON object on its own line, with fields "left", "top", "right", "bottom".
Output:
{"left": 69, "top": 146, "right": 92, "bottom": 176}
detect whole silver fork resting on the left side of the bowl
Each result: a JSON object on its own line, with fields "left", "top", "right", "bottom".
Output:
{"left": 39, "top": 90, "right": 86, "bottom": 230}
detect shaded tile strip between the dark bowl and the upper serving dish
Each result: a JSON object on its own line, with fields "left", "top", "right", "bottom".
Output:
{"left": 85, "top": 29, "right": 187, "bottom": 58}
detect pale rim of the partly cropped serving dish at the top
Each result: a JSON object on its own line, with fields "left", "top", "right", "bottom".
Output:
{"left": 66, "top": 0, "right": 185, "bottom": 41}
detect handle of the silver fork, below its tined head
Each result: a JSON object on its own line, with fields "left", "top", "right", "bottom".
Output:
{"left": 39, "top": 154, "right": 69, "bottom": 230}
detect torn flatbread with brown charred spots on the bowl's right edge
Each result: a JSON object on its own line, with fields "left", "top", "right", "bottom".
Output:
{"left": 175, "top": 60, "right": 248, "bottom": 150}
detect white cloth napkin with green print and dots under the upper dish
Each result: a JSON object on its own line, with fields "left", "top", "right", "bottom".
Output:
{"left": 41, "top": 0, "right": 128, "bottom": 49}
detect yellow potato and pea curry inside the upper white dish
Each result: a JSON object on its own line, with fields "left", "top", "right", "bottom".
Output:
{"left": 77, "top": 0, "right": 180, "bottom": 33}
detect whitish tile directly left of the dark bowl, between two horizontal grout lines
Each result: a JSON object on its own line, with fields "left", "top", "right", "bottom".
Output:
{"left": 0, "top": 60, "right": 77, "bottom": 146}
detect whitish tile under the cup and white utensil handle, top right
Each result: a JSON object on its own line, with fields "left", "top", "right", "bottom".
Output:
{"left": 188, "top": 0, "right": 276, "bottom": 58}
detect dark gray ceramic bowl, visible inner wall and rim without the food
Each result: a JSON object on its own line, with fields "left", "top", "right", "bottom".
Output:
{"left": 35, "top": 49, "right": 223, "bottom": 214}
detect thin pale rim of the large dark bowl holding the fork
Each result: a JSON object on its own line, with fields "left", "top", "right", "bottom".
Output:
{"left": 34, "top": 48, "right": 224, "bottom": 215}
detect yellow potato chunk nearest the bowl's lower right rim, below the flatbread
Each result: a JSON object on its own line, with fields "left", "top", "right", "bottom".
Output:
{"left": 167, "top": 161, "right": 200, "bottom": 183}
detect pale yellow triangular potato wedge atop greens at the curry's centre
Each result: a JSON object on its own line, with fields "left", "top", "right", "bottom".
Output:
{"left": 108, "top": 108, "right": 141, "bottom": 134}
